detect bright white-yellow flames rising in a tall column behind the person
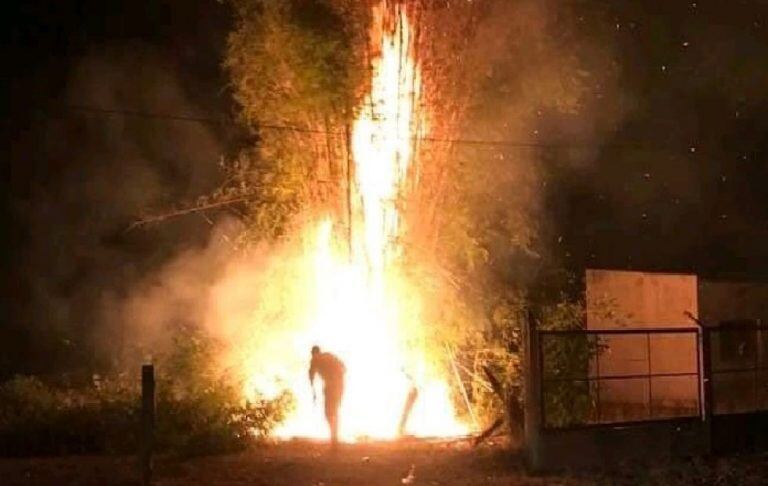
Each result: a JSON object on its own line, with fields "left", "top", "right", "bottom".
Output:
{"left": 238, "top": 2, "right": 467, "bottom": 441}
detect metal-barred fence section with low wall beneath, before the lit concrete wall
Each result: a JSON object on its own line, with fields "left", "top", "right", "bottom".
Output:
{"left": 525, "top": 320, "right": 709, "bottom": 469}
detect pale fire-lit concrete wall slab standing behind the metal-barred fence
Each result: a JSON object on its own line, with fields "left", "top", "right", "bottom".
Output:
{"left": 586, "top": 270, "right": 699, "bottom": 414}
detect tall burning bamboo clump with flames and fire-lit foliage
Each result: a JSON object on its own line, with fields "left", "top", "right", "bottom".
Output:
{"left": 126, "top": 0, "right": 616, "bottom": 444}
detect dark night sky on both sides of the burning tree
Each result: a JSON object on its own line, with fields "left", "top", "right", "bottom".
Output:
{"left": 0, "top": 0, "right": 768, "bottom": 374}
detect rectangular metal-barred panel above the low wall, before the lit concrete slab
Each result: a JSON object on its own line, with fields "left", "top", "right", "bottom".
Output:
{"left": 537, "top": 328, "right": 702, "bottom": 430}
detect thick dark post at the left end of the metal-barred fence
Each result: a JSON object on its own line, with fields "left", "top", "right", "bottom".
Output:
{"left": 523, "top": 310, "right": 542, "bottom": 470}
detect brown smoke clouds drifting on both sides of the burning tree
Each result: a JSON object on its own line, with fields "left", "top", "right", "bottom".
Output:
{"left": 4, "top": 1, "right": 623, "bottom": 378}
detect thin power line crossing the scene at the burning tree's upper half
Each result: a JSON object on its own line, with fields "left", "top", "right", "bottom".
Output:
{"left": 39, "top": 105, "right": 697, "bottom": 153}
